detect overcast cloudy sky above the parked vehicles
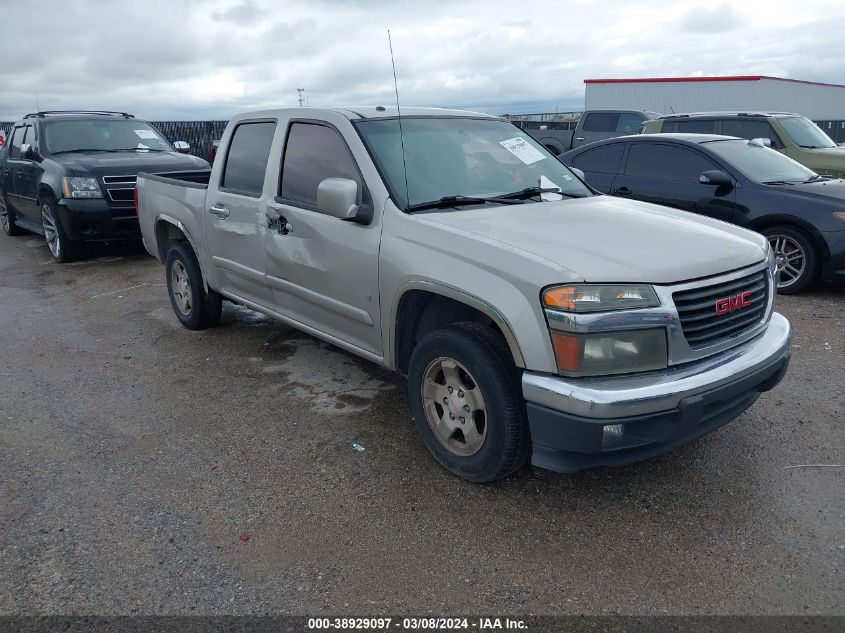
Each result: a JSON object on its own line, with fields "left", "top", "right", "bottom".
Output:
{"left": 0, "top": 0, "right": 845, "bottom": 120}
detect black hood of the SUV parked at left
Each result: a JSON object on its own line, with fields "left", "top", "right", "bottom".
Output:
{"left": 49, "top": 151, "right": 209, "bottom": 177}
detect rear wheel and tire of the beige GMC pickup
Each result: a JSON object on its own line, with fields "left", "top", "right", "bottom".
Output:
{"left": 165, "top": 242, "right": 223, "bottom": 330}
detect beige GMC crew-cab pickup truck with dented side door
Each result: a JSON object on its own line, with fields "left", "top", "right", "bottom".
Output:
{"left": 136, "top": 106, "right": 791, "bottom": 482}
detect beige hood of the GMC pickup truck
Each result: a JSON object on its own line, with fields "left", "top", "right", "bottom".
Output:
{"left": 419, "top": 196, "right": 767, "bottom": 284}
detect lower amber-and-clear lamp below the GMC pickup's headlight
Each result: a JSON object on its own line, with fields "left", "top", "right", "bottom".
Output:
{"left": 551, "top": 328, "right": 668, "bottom": 376}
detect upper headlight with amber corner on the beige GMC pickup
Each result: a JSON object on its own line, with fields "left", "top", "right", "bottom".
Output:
{"left": 543, "top": 284, "right": 660, "bottom": 312}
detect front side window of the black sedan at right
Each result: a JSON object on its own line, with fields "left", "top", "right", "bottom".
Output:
{"left": 625, "top": 143, "right": 719, "bottom": 182}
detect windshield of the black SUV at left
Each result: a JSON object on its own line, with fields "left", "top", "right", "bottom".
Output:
{"left": 42, "top": 119, "right": 173, "bottom": 154}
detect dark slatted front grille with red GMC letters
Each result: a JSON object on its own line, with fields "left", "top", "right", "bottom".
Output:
{"left": 672, "top": 269, "right": 769, "bottom": 349}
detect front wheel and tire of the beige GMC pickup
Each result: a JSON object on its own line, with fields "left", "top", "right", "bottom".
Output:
{"left": 408, "top": 323, "right": 531, "bottom": 482}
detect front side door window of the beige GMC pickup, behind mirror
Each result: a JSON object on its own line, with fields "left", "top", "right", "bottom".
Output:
{"left": 279, "top": 123, "right": 362, "bottom": 209}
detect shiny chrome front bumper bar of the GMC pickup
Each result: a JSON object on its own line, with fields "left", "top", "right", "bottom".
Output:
{"left": 522, "top": 312, "right": 792, "bottom": 420}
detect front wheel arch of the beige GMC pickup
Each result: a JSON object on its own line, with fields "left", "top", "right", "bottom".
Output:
{"left": 388, "top": 281, "right": 525, "bottom": 374}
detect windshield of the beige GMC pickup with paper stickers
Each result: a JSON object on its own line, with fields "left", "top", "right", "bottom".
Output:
{"left": 357, "top": 117, "right": 592, "bottom": 208}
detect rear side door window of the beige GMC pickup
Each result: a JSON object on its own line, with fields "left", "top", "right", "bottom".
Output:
{"left": 220, "top": 121, "right": 276, "bottom": 198}
